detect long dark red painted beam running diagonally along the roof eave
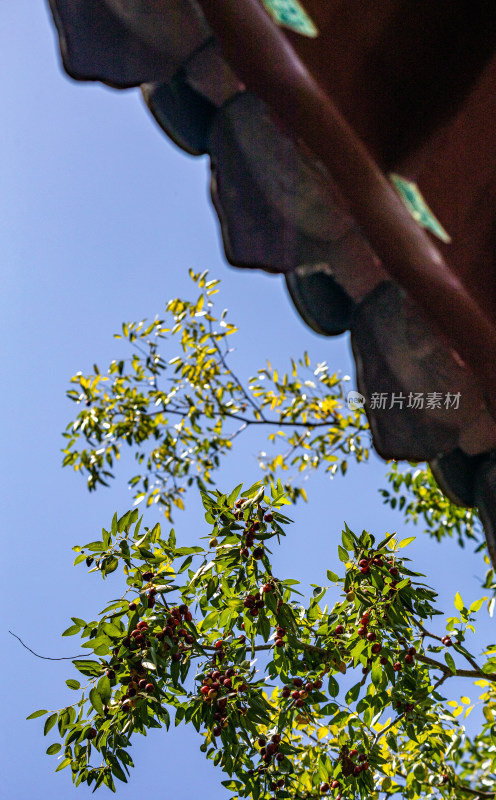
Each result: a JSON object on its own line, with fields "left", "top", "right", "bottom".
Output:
{"left": 198, "top": 0, "right": 496, "bottom": 419}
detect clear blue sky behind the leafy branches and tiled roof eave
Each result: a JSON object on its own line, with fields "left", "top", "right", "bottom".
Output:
{"left": 0, "top": 0, "right": 493, "bottom": 800}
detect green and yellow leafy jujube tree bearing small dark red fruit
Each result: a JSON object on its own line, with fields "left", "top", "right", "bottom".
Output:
{"left": 26, "top": 274, "right": 496, "bottom": 800}
